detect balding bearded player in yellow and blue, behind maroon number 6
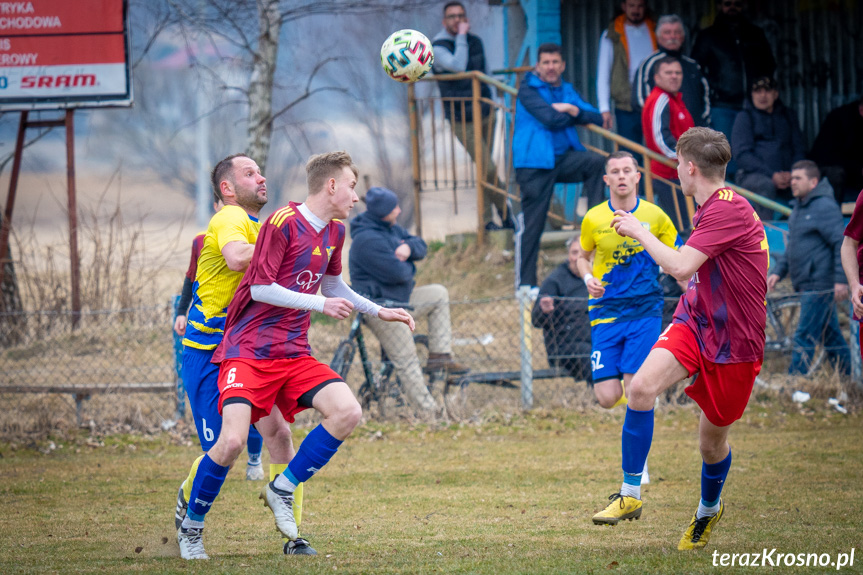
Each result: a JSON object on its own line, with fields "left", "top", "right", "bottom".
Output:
{"left": 174, "top": 154, "right": 315, "bottom": 555}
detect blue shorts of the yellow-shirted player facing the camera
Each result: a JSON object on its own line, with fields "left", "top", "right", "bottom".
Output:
{"left": 590, "top": 317, "right": 662, "bottom": 383}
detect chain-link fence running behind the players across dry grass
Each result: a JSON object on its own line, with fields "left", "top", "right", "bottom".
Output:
{"left": 0, "top": 294, "right": 860, "bottom": 439}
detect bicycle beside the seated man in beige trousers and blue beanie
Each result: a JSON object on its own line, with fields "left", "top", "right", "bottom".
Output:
{"left": 330, "top": 313, "right": 438, "bottom": 418}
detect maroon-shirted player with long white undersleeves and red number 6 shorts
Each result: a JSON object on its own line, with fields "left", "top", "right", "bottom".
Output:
{"left": 177, "top": 152, "right": 414, "bottom": 559}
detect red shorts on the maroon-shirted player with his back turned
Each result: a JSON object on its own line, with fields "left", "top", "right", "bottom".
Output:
{"left": 653, "top": 323, "right": 761, "bottom": 427}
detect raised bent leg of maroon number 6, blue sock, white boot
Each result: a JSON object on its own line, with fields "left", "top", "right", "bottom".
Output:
{"left": 266, "top": 381, "right": 362, "bottom": 540}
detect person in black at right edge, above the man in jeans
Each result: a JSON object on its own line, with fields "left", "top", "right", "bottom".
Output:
{"left": 809, "top": 98, "right": 863, "bottom": 203}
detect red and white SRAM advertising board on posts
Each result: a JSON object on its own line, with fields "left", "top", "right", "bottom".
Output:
{"left": 0, "top": 0, "right": 132, "bottom": 111}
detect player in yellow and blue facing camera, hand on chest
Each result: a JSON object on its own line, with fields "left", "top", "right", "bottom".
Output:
{"left": 578, "top": 152, "right": 682, "bottom": 430}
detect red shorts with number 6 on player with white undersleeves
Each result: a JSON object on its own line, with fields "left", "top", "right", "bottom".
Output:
{"left": 219, "top": 356, "right": 342, "bottom": 423}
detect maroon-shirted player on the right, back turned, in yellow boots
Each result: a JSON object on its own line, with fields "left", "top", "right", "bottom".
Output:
{"left": 593, "top": 128, "right": 769, "bottom": 550}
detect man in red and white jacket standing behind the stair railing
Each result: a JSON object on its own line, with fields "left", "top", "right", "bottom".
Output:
{"left": 641, "top": 56, "right": 695, "bottom": 229}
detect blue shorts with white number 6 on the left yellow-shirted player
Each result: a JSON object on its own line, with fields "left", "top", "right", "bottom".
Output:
{"left": 183, "top": 346, "right": 260, "bottom": 451}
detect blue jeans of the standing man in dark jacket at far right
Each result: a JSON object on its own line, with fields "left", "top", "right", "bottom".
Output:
{"left": 788, "top": 290, "right": 851, "bottom": 376}
